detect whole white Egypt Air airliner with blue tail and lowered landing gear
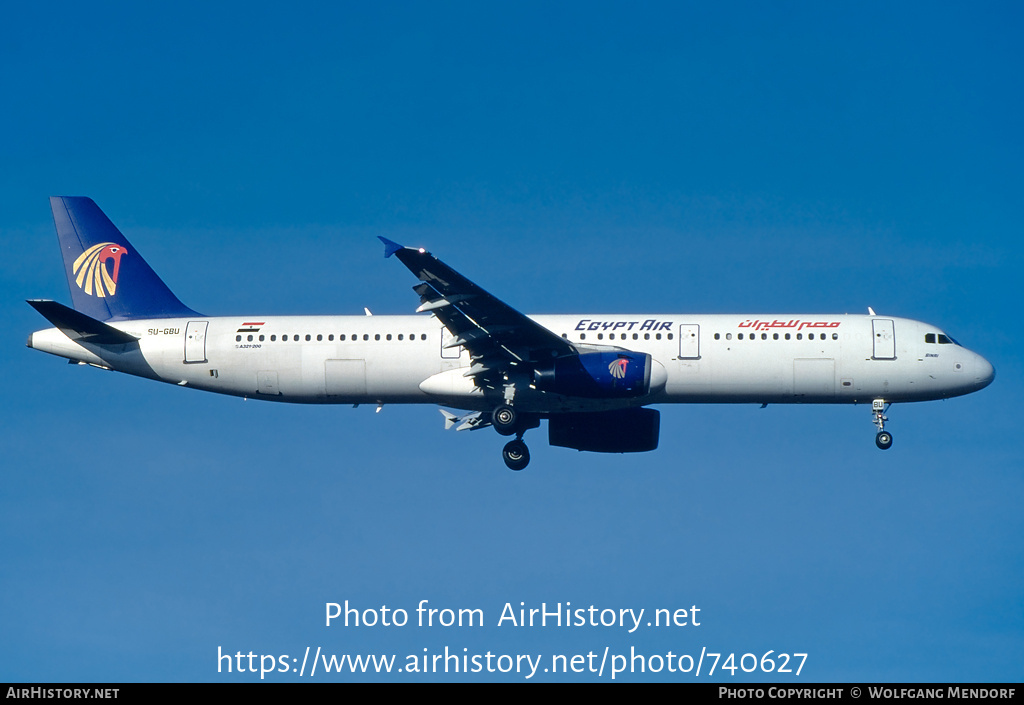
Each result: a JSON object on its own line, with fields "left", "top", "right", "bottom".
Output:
{"left": 28, "top": 197, "right": 995, "bottom": 470}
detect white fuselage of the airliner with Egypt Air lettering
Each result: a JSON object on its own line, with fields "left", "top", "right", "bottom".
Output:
{"left": 28, "top": 314, "right": 993, "bottom": 413}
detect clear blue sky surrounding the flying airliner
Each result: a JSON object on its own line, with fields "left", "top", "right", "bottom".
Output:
{"left": 0, "top": 2, "right": 1024, "bottom": 683}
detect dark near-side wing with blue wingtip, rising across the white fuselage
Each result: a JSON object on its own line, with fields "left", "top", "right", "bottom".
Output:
{"left": 380, "top": 238, "right": 579, "bottom": 381}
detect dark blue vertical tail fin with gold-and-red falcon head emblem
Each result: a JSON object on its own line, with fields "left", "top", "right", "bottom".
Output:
{"left": 50, "top": 196, "right": 201, "bottom": 321}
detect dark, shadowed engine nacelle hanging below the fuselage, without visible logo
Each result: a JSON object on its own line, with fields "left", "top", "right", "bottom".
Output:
{"left": 548, "top": 409, "right": 662, "bottom": 453}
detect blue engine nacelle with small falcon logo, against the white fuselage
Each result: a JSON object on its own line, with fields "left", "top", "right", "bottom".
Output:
{"left": 534, "top": 351, "right": 651, "bottom": 399}
